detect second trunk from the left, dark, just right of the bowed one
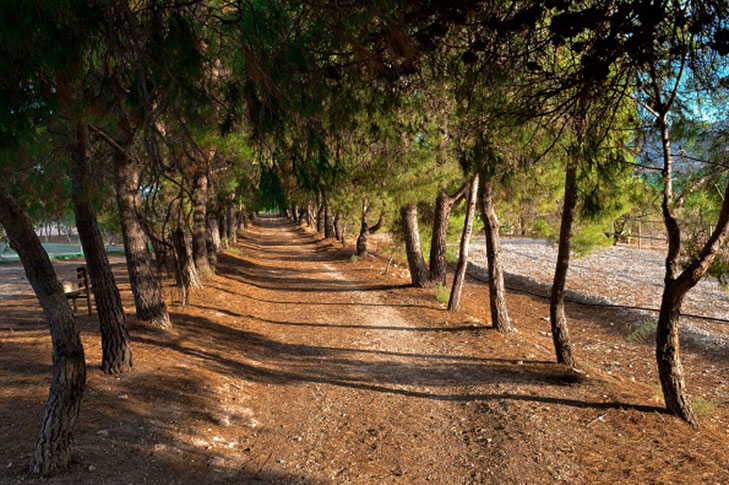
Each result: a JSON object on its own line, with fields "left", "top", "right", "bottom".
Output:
{"left": 71, "top": 123, "right": 132, "bottom": 374}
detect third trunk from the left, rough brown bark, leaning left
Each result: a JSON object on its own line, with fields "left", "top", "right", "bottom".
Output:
{"left": 114, "top": 132, "right": 171, "bottom": 328}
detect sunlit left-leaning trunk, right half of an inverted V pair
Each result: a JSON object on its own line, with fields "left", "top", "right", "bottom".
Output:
{"left": 481, "top": 174, "right": 513, "bottom": 334}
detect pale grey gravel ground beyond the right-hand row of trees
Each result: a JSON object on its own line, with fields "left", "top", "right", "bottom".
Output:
{"left": 471, "top": 236, "right": 729, "bottom": 351}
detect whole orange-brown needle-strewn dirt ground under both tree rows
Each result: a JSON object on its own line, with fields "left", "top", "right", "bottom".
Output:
{"left": 0, "top": 219, "right": 729, "bottom": 485}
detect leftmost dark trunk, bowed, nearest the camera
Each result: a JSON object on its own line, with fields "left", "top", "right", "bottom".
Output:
{"left": 0, "top": 187, "right": 86, "bottom": 475}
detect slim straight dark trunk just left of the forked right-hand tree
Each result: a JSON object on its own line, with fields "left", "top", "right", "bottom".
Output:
{"left": 549, "top": 161, "right": 577, "bottom": 367}
